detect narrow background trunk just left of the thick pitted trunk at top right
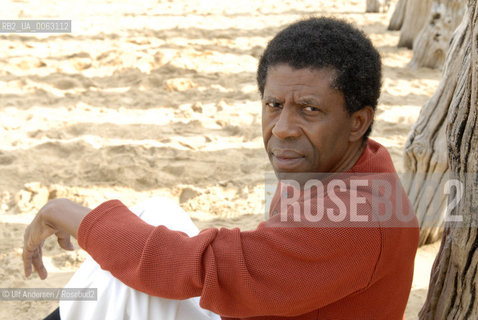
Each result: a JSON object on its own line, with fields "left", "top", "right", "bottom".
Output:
{"left": 398, "top": 0, "right": 432, "bottom": 49}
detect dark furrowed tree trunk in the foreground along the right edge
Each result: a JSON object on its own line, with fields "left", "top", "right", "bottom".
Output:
{"left": 419, "top": 0, "right": 478, "bottom": 320}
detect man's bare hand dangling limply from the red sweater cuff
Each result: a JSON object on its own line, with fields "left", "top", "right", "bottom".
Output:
{"left": 22, "top": 199, "right": 91, "bottom": 280}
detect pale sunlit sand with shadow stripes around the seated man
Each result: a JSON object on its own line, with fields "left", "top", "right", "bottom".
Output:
{"left": 0, "top": 0, "right": 441, "bottom": 319}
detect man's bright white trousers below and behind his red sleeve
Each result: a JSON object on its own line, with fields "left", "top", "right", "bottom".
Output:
{"left": 60, "top": 198, "right": 220, "bottom": 320}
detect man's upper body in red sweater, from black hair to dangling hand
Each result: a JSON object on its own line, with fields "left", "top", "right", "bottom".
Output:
{"left": 23, "top": 18, "right": 418, "bottom": 319}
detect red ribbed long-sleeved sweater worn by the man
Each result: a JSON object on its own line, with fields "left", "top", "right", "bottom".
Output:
{"left": 78, "top": 139, "right": 418, "bottom": 320}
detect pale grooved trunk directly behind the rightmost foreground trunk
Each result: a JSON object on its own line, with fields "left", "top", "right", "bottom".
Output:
{"left": 403, "top": 10, "right": 471, "bottom": 245}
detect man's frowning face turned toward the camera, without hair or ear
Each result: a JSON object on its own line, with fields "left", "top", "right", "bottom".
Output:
{"left": 262, "top": 64, "right": 353, "bottom": 178}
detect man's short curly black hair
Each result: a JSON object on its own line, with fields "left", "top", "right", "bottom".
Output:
{"left": 257, "top": 17, "right": 382, "bottom": 139}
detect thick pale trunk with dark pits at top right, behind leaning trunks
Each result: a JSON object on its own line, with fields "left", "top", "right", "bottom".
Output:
{"left": 409, "top": 0, "right": 466, "bottom": 68}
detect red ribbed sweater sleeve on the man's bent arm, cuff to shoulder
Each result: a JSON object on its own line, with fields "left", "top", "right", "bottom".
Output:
{"left": 78, "top": 200, "right": 381, "bottom": 317}
